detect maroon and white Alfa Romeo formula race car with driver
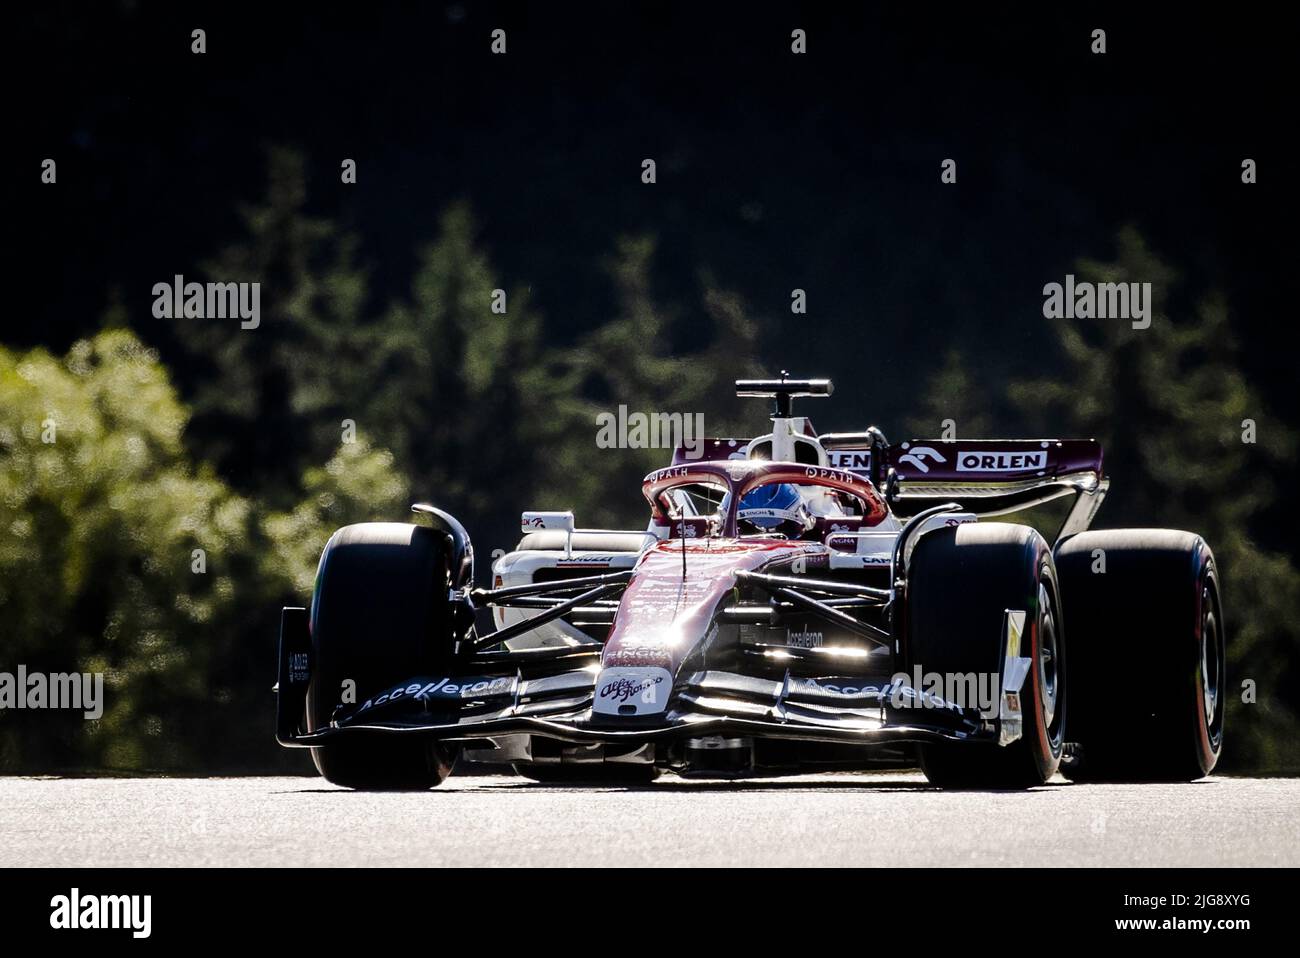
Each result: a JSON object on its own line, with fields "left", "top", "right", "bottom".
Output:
{"left": 277, "top": 377, "right": 1226, "bottom": 788}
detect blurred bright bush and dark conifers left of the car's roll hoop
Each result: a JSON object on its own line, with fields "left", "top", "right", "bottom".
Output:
{"left": 0, "top": 151, "right": 758, "bottom": 771}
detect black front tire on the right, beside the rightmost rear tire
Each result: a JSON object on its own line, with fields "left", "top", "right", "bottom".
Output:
{"left": 907, "top": 523, "right": 1066, "bottom": 789}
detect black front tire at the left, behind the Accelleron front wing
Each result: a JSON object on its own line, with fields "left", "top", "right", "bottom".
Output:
{"left": 307, "top": 523, "right": 455, "bottom": 789}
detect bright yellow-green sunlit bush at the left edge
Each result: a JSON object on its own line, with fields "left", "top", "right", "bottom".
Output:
{"left": 0, "top": 329, "right": 406, "bottom": 770}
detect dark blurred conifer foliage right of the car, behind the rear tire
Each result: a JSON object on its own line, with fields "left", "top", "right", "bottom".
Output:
{"left": 1008, "top": 229, "right": 1300, "bottom": 772}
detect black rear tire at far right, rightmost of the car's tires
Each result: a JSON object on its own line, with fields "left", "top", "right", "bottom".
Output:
{"left": 1057, "top": 529, "right": 1227, "bottom": 781}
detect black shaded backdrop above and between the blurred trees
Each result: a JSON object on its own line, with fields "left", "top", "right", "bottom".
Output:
{"left": 0, "top": 3, "right": 1300, "bottom": 767}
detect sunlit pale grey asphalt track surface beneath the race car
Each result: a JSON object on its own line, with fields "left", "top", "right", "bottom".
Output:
{"left": 0, "top": 772, "right": 1300, "bottom": 868}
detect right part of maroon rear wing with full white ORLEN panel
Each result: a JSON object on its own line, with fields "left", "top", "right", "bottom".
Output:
{"left": 885, "top": 439, "right": 1110, "bottom": 537}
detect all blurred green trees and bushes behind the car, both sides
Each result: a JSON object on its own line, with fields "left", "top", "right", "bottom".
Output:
{"left": 0, "top": 157, "right": 1300, "bottom": 771}
